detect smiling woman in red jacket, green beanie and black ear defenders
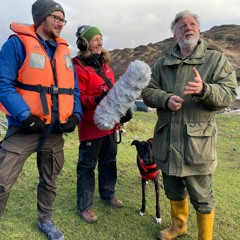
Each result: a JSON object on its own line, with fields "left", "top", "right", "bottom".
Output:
{"left": 73, "top": 25, "right": 123, "bottom": 223}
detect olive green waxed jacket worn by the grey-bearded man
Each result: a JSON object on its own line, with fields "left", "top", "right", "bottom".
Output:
{"left": 142, "top": 39, "right": 237, "bottom": 176}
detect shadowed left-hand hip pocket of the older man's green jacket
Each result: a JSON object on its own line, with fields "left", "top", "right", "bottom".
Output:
{"left": 152, "top": 121, "right": 169, "bottom": 162}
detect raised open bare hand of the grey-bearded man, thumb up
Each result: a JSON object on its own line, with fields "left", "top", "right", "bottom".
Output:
{"left": 183, "top": 67, "right": 203, "bottom": 95}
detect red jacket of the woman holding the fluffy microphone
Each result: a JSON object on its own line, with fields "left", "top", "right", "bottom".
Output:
{"left": 73, "top": 57, "right": 115, "bottom": 142}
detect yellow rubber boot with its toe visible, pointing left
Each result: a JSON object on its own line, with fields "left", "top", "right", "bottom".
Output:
{"left": 158, "top": 198, "right": 188, "bottom": 240}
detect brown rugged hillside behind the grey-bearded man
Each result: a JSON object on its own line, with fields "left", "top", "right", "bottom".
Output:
{"left": 111, "top": 25, "right": 240, "bottom": 82}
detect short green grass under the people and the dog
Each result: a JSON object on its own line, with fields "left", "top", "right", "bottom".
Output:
{"left": 0, "top": 112, "right": 240, "bottom": 240}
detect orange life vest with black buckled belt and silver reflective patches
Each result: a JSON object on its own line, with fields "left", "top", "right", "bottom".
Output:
{"left": 6, "top": 23, "right": 74, "bottom": 124}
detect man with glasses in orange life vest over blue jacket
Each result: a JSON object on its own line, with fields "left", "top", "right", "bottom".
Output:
{"left": 0, "top": 0, "right": 82, "bottom": 240}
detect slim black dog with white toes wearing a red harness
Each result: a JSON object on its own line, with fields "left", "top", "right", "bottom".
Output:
{"left": 131, "top": 138, "right": 162, "bottom": 223}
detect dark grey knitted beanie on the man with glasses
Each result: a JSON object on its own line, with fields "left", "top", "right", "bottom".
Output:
{"left": 32, "top": 0, "right": 65, "bottom": 27}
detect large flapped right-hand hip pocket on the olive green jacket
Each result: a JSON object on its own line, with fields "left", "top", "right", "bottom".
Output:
{"left": 185, "top": 122, "right": 217, "bottom": 165}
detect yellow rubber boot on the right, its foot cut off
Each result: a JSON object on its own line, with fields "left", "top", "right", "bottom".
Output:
{"left": 197, "top": 210, "right": 214, "bottom": 240}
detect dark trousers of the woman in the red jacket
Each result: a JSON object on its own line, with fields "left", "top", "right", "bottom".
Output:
{"left": 77, "top": 135, "right": 117, "bottom": 212}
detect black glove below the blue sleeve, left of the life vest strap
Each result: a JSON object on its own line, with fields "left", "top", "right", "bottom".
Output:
{"left": 22, "top": 114, "right": 46, "bottom": 133}
